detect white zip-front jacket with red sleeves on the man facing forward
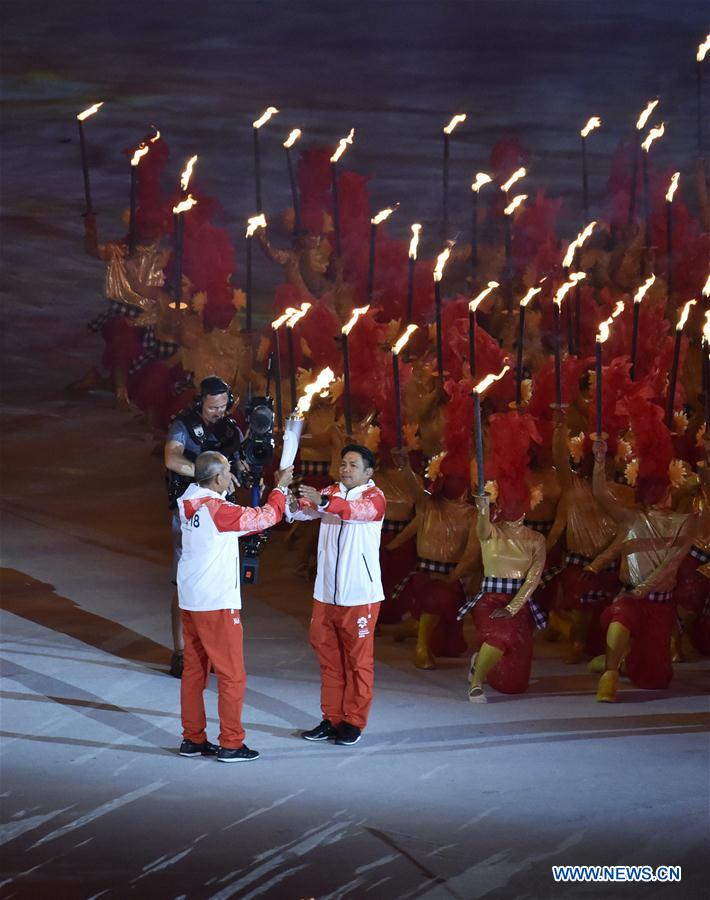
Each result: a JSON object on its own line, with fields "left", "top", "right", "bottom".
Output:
{"left": 286, "top": 481, "right": 387, "bottom": 606}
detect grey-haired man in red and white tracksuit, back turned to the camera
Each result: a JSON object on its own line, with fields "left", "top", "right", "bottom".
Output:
{"left": 177, "top": 451, "right": 293, "bottom": 762}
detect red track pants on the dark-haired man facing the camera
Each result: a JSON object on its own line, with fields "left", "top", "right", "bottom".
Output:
{"left": 309, "top": 600, "right": 380, "bottom": 728}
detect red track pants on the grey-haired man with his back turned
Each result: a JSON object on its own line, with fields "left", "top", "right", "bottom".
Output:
{"left": 180, "top": 609, "right": 247, "bottom": 750}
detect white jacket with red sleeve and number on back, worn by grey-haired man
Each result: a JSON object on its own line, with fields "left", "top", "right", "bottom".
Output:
{"left": 177, "top": 484, "right": 286, "bottom": 612}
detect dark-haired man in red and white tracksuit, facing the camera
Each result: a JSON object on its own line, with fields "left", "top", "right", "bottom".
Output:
{"left": 286, "top": 444, "right": 386, "bottom": 746}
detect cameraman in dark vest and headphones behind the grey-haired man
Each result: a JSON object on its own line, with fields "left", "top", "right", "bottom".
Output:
{"left": 164, "top": 375, "right": 244, "bottom": 678}
